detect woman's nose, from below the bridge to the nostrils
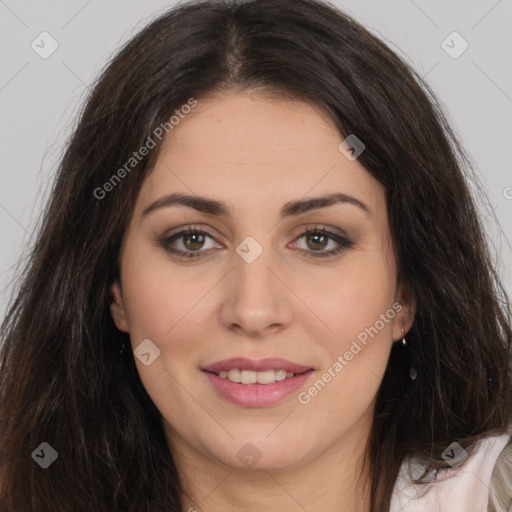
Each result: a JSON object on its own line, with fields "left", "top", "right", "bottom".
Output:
{"left": 220, "top": 241, "right": 293, "bottom": 339}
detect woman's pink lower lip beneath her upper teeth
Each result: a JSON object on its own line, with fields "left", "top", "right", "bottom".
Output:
{"left": 203, "top": 370, "right": 313, "bottom": 407}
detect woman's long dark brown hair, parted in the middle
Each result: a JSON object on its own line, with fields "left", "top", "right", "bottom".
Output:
{"left": 0, "top": 0, "right": 512, "bottom": 512}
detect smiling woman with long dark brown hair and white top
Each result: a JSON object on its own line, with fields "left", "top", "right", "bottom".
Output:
{"left": 0, "top": 0, "right": 512, "bottom": 512}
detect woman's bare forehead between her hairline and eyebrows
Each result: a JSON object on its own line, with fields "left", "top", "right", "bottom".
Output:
{"left": 136, "top": 92, "right": 383, "bottom": 217}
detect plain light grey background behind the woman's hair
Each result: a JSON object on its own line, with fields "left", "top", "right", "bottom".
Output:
{"left": 0, "top": 0, "right": 512, "bottom": 319}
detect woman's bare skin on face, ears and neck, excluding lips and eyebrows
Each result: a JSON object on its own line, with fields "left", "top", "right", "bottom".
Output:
{"left": 111, "top": 91, "right": 414, "bottom": 512}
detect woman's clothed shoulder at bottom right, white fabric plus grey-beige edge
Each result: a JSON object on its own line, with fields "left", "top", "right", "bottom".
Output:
{"left": 390, "top": 425, "right": 512, "bottom": 512}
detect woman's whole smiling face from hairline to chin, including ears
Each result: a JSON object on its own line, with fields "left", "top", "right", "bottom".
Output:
{"left": 111, "top": 92, "right": 412, "bottom": 470}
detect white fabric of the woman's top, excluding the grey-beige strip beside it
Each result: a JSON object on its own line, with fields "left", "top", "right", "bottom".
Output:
{"left": 389, "top": 431, "right": 512, "bottom": 512}
